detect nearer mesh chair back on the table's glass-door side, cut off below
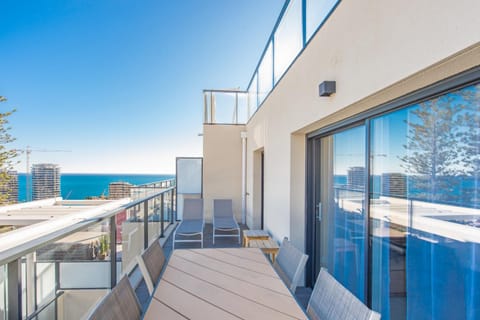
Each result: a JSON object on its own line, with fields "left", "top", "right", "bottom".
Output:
{"left": 307, "top": 268, "right": 380, "bottom": 320}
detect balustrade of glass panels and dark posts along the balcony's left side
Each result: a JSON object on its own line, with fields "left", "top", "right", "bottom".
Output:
{"left": 0, "top": 180, "right": 176, "bottom": 320}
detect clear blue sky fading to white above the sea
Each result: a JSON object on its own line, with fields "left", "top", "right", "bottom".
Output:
{"left": 0, "top": 0, "right": 284, "bottom": 173}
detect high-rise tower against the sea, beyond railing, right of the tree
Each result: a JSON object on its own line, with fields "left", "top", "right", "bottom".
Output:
{"left": 32, "top": 163, "right": 60, "bottom": 200}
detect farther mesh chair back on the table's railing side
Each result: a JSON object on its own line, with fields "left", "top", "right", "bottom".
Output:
{"left": 137, "top": 240, "right": 166, "bottom": 294}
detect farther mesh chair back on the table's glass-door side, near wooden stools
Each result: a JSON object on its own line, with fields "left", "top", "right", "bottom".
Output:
{"left": 273, "top": 239, "right": 308, "bottom": 293}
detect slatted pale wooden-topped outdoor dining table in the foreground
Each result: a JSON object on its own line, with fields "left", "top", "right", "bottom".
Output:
{"left": 144, "top": 248, "right": 307, "bottom": 320}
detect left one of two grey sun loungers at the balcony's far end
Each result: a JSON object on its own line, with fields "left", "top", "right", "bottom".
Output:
{"left": 172, "top": 199, "right": 205, "bottom": 250}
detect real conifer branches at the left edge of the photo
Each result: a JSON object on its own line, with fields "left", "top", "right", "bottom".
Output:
{"left": 0, "top": 96, "right": 18, "bottom": 205}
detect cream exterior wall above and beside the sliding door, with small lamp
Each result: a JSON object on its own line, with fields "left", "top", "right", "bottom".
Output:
{"left": 247, "top": 0, "right": 480, "bottom": 248}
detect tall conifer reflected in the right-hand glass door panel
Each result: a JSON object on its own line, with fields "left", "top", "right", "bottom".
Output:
{"left": 400, "top": 94, "right": 462, "bottom": 201}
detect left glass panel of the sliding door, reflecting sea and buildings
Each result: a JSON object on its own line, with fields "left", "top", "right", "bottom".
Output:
{"left": 312, "top": 125, "right": 367, "bottom": 301}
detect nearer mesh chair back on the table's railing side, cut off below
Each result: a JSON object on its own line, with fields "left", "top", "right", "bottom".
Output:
{"left": 88, "top": 275, "right": 142, "bottom": 320}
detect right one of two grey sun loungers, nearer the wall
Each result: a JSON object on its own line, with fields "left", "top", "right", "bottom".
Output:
{"left": 213, "top": 199, "right": 240, "bottom": 244}
